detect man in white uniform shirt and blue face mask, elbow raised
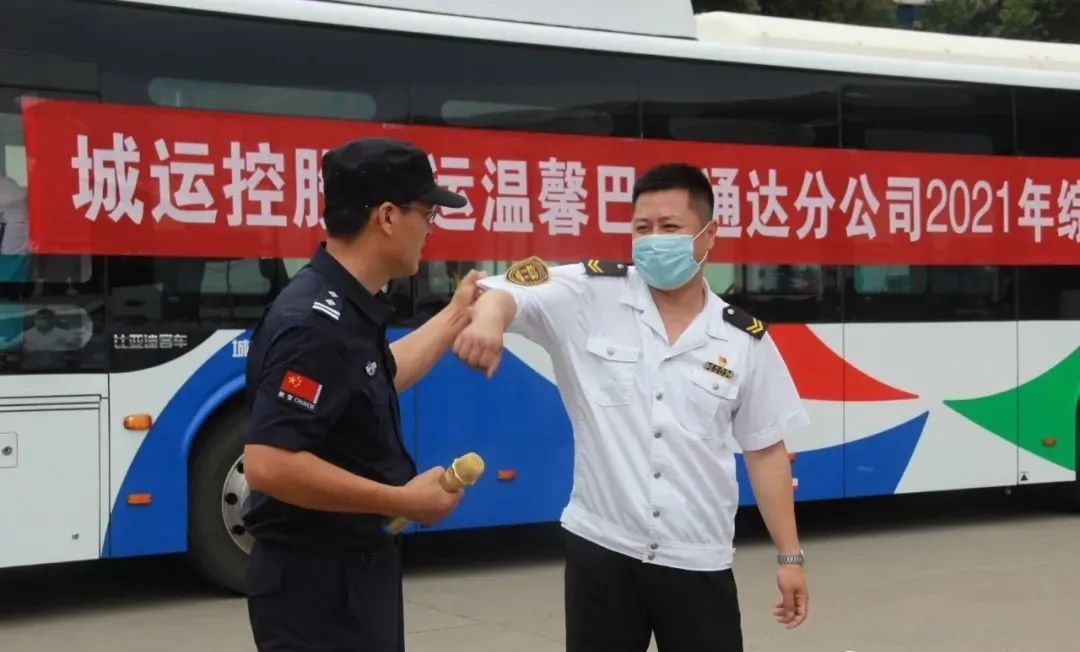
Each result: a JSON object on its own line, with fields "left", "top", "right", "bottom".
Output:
{"left": 454, "top": 164, "right": 808, "bottom": 652}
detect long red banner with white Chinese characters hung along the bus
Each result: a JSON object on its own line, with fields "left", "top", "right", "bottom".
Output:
{"left": 24, "top": 100, "right": 1080, "bottom": 264}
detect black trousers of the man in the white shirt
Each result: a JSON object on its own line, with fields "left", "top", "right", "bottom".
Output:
{"left": 565, "top": 532, "right": 743, "bottom": 652}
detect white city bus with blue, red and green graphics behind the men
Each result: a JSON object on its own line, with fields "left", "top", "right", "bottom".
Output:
{"left": 0, "top": 0, "right": 1080, "bottom": 589}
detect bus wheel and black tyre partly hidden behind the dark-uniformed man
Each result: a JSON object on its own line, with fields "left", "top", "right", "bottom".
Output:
{"left": 188, "top": 406, "right": 252, "bottom": 594}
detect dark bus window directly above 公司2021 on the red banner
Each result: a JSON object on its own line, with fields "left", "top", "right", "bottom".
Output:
{"left": 841, "top": 79, "right": 1014, "bottom": 154}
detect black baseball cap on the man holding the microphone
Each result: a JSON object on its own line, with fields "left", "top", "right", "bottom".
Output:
{"left": 323, "top": 138, "right": 468, "bottom": 212}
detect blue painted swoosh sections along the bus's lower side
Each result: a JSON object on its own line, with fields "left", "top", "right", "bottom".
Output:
{"left": 103, "top": 330, "right": 929, "bottom": 557}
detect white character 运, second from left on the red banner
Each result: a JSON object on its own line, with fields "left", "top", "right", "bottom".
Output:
{"left": 150, "top": 138, "right": 217, "bottom": 225}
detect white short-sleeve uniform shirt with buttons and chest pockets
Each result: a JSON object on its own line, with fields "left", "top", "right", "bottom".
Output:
{"left": 481, "top": 263, "right": 808, "bottom": 570}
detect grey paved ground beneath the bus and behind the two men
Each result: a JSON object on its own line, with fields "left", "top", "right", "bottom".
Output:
{"left": 0, "top": 492, "right": 1080, "bottom": 652}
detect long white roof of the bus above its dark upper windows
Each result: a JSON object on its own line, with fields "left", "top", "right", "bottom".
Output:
{"left": 116, "top": 0, "right": 1080, "bottom": 90}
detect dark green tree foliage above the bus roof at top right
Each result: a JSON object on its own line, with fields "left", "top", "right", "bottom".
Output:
{"left": 693, "top": 0, "right": 1080, "bottom": 43}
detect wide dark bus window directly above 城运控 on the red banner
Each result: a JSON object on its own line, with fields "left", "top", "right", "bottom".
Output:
{"left": 97, "top": 0, "right": 412, "bottom": 122}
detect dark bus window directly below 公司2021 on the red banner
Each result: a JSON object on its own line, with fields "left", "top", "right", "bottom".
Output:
{"left": 845, "top": 264, "right": 1016, "bottom": 323}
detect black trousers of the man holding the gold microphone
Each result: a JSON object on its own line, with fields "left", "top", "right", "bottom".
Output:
{"left": 246, "top": 542, "right": 405, "bottom": 652}
